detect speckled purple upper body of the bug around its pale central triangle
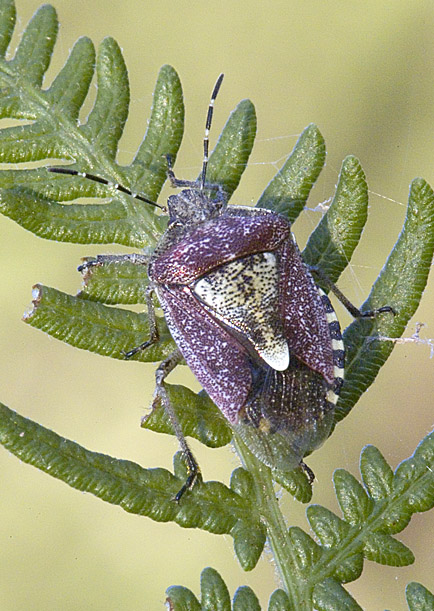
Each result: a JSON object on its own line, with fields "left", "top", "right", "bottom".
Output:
{"left": 149, "top": 201, "right": 334, "bottom": 430}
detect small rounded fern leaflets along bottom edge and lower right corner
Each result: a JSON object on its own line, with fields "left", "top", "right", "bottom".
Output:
{"left": 162, "top": 434, "right": 434, "bottom": 611}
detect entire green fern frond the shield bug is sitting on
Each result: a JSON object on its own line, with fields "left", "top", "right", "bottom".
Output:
{"left": 0, "top": 0, "right": 434, "bottom": 611}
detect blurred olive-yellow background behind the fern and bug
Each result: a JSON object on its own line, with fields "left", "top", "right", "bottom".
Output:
{"left": 0, "top": 0, "right": 434, "bottom": 611}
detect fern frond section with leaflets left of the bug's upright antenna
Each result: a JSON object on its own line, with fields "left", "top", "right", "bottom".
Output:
{"left": 0, "top": 3, "right": 184, "bottom": 247}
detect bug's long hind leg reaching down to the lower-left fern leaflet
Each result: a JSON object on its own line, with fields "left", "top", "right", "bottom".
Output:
{"left": 153, "top": 349, "right": 200, "bottom": 503}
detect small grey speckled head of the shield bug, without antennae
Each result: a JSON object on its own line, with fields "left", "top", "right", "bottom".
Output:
{"left": 167, "top": 187, "right": 225, "bottom": 226}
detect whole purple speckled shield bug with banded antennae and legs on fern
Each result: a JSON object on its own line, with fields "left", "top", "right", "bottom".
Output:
{"left": 49, "top": 75, "right": 393, "bottom": 501}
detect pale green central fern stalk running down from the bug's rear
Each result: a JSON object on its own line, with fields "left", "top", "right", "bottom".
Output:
{"left": 234, "top": 434, "right": 312, "bottom": 611}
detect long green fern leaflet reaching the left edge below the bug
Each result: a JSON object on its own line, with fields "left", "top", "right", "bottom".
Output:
{"left": 0, "top": 404, "right": 265, "bottom": 571}
